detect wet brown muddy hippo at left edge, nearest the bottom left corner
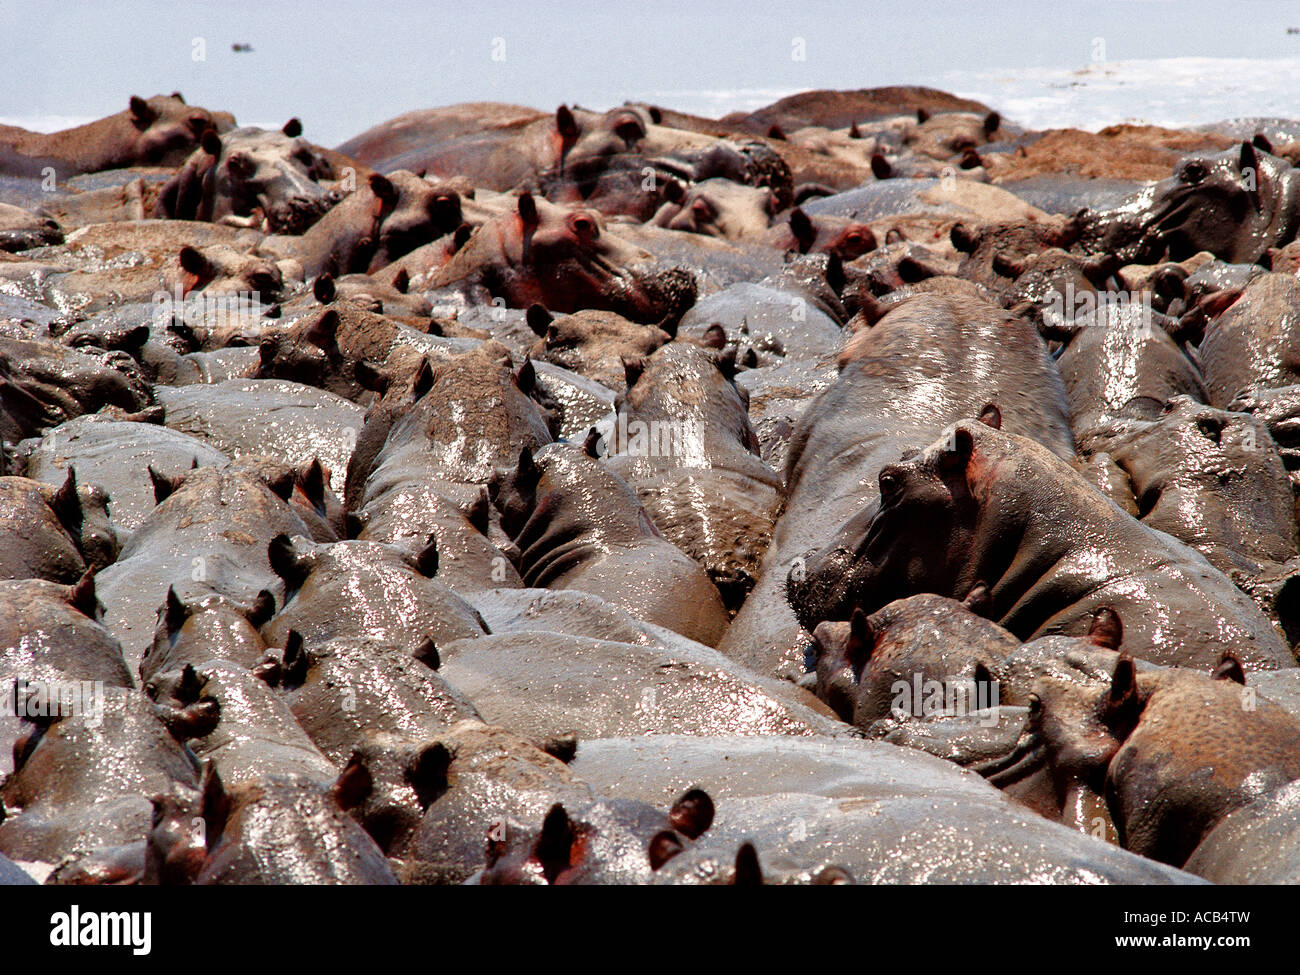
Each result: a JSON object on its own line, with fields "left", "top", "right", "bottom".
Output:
{"left": 0, "top": 688, "right": 199, "bottom": 880}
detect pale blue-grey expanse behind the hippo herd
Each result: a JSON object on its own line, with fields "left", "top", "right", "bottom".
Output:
{"left": 0, "top": 0, "right": 1300, "bottom": 146}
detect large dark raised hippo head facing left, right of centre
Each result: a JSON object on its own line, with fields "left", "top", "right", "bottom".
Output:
{"left": 787, "top": 406, "right": 1001, "bottom": 631}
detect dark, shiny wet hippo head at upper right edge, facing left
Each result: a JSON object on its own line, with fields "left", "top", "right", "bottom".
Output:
{"left": 1112, "top": 142, "right": 1300, "bottom": 264}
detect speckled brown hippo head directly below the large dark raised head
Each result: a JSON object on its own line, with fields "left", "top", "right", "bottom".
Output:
{"left": 813, "top": 590, "right": 1019, "bottom": 731}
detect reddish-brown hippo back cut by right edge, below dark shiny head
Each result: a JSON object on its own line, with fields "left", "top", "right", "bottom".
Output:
{"left": 1200, "top": 274, "right": 1300, "bottom": 408}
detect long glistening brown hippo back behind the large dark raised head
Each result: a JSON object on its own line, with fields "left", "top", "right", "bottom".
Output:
{"left": 720, "top": 294, "right": 1074, "bottom": 675}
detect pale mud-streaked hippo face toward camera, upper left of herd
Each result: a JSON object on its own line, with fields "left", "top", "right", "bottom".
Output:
{"left": 205, "top": 120, "right": 339, "bottom": 234}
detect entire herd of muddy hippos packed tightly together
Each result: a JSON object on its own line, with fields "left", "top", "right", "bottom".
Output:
{"left": 0, "top": 88, "right": 1300, "bottom": 884}
